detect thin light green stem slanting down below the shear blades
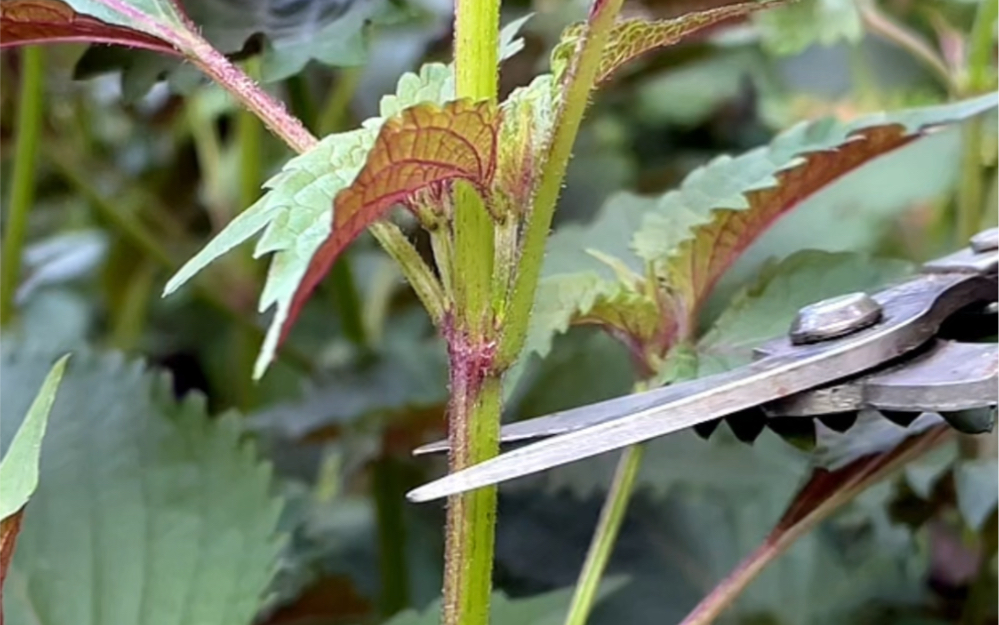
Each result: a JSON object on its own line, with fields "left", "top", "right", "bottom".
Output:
{"left": 565, "top": 445, "right": 645, "bottom": 625}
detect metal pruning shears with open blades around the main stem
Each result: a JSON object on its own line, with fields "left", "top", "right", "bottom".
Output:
{"left": 408, "top": 228, "right": 999, "bottom": 501}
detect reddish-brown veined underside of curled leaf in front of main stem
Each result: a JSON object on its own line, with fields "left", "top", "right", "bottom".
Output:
{"left": 281, "top": 100, "right": 500, "bottom": 340}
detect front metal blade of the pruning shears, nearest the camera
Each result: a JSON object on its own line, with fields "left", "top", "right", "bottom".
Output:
{"left": 408, "top": 273, "right": 996, "bottom": 501}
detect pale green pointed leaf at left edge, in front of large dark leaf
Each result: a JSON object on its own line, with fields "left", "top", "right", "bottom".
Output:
{"left": 0, "top": 355, "right": 69, "bottom": 520}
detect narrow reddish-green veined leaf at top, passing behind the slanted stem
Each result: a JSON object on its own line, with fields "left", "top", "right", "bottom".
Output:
{"left": 552, "top": 0, "right": 785, "bottom": 85}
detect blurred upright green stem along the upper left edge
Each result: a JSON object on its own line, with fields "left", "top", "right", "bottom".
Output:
{"left": 0, "top": 46, "right": 45, "bottom": 326}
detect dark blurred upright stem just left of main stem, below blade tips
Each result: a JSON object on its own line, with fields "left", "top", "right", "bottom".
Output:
{"left": 371, "top": 457, "right": 409, "bottom": 618}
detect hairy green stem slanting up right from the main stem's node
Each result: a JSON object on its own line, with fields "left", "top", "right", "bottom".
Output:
{"left": 497, "top": 0, "right": 624, "bottom": 368}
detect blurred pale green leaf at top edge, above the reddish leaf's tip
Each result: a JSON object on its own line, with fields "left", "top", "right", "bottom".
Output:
{"left": 755, "top": 0, "right": 864, "bottom": 55}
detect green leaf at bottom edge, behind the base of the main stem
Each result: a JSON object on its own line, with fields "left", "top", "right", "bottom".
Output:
{"left": 386, "top": 578, "right": 624, "bottom": 625}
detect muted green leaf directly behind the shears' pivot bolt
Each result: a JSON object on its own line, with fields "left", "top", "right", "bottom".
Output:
{"left": 697, "top": 250, "right": 912, "bottom": 376}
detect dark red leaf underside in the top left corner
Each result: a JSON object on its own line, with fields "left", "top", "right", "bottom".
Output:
{"left": 0, "top": 0, "right": 180, "bottom": 55}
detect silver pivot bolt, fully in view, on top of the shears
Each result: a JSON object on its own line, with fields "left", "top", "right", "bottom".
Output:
{"left": 790, "top": 293, "right": 881, "bottom": 345}
